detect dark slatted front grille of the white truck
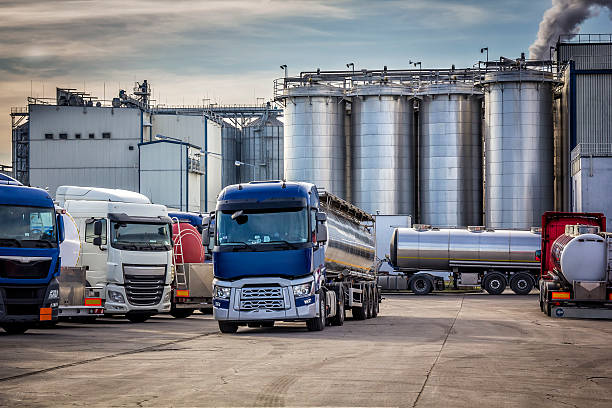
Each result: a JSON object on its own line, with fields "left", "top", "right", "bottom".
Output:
{"left": 123, "top": 266, "right": 166, "bottom": 306}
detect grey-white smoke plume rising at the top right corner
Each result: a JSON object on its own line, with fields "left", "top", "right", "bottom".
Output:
{"left": 529, "top": 0, "right": 612, "bottom": 59}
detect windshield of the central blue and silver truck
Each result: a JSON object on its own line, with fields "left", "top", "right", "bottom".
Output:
{"left": 217, "top": 208, "right": 309, "bottom": 247}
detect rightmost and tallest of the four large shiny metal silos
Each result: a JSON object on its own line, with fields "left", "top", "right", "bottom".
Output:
{"left": 483, "top": 70, "right": 553, "bottom": 229}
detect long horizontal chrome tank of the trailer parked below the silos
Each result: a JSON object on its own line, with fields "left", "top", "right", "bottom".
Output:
{"left": 390, "top": 226, "right": 541, "bottom": 271}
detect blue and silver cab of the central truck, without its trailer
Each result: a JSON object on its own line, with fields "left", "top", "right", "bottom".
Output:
{"left": 205, "top": 182, "right": 327, "bottom": 333}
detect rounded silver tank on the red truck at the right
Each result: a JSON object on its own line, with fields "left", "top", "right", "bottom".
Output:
{"left": 550, "top": 225, "right": 608, "bottom": 284}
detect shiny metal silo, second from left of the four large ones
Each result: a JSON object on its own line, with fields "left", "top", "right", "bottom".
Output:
{"left": 349, "top": 84, "right": 416, "bottom": 215}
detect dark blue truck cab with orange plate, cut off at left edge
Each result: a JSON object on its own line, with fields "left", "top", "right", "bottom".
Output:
{"left": 0, "top": 178, "right": 63, "bottom": 334}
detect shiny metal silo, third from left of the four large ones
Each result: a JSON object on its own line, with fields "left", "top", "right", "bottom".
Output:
{"left": 419, "top": 83, "right": 482, "bottom": 227}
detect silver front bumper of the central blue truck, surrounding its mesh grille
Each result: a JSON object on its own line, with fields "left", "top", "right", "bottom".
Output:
{"left": 213, "top": 277, "right": 318, "bottom": 322}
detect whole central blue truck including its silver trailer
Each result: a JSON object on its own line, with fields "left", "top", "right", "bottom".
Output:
{"left": 204, "top": 181, "right": 380, "bottom": 333}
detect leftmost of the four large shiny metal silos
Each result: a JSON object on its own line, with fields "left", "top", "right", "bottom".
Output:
{"left": 284, "top": 84, "right": 346, "bottom": 198}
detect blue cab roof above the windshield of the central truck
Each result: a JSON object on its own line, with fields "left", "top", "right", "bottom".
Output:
{"left": 217, "top": 181, "right": 319, "bottom": 210}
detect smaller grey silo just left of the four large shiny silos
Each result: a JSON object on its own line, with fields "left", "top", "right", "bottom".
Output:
{"left": 239, "top": 115, "right": 284, "bottom": 183}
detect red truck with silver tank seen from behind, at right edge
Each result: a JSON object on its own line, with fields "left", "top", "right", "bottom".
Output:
{"left": 540, "top": 212, "right": 612, "bottom": 319}
